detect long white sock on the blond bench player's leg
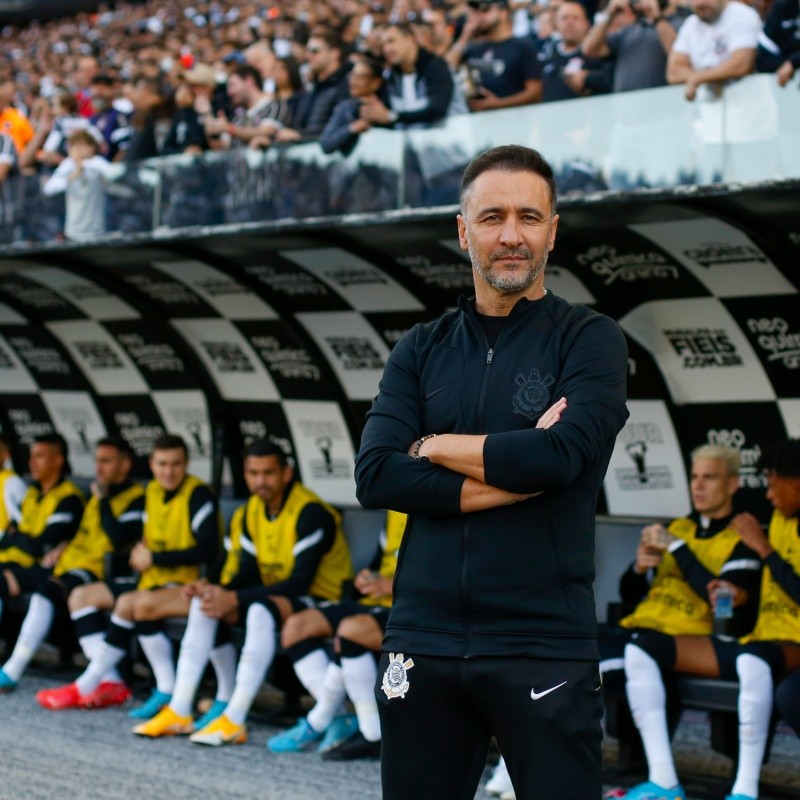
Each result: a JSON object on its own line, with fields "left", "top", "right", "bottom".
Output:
{"left": 625, "top": 644, "right": 678, "bottom": 789}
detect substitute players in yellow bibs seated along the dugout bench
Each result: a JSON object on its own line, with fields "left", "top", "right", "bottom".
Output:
{"left": 0, "top": 424, "right": 800, "bottom": 800}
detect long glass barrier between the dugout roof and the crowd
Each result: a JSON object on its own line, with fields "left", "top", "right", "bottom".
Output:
{"left": 0, "top": 75, "right": 800, "bottom": 245}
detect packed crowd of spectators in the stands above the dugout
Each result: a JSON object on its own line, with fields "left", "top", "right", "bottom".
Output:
{"left": 0, "top": 0, "right": 800, "bottom": 239}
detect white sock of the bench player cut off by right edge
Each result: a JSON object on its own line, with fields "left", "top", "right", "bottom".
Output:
{"left": 731, "top": 653, "right": 774, "bottom": 797}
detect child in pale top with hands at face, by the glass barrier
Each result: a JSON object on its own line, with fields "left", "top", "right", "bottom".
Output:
{"left": 42, "top": 130, "right": 113, "bottom": 242}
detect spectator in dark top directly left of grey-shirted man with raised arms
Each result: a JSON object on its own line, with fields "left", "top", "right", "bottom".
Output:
{"left": 537, "top": 0, "right": 613, "bottom": 102}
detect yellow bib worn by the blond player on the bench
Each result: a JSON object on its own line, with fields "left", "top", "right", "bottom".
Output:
{"left": 619, "top": 517, "right": 739, "bottom": 636}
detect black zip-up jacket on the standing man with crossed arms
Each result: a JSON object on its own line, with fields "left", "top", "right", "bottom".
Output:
{"left": 356, "top": 294, "right": 628, "bottom": 660}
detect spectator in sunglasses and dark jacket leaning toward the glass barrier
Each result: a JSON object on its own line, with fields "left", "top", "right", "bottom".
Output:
{"left": 275, "top": 28, "right": 350, "bottom": 142}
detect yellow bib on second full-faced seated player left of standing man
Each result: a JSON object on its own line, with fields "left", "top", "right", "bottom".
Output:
{"left": 138, "top": 475, "right": 209, "bottom": 589}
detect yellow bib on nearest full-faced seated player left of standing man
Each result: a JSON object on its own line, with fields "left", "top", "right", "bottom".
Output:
{"left": 242, "top": 483, "right": 353, "bottom": 600}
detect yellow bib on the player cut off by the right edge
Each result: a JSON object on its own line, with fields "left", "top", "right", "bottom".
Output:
{"left": 741, "top": 511, "right": 800, "bottom": 644}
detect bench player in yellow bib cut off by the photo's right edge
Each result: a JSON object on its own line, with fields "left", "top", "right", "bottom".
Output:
{"left": 727, "top": 439, "right": 800, "bottom": 800}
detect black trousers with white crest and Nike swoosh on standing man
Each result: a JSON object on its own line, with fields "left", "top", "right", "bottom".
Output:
{"left": 375, "top": 653, "right": 603, "bottom": 800}
